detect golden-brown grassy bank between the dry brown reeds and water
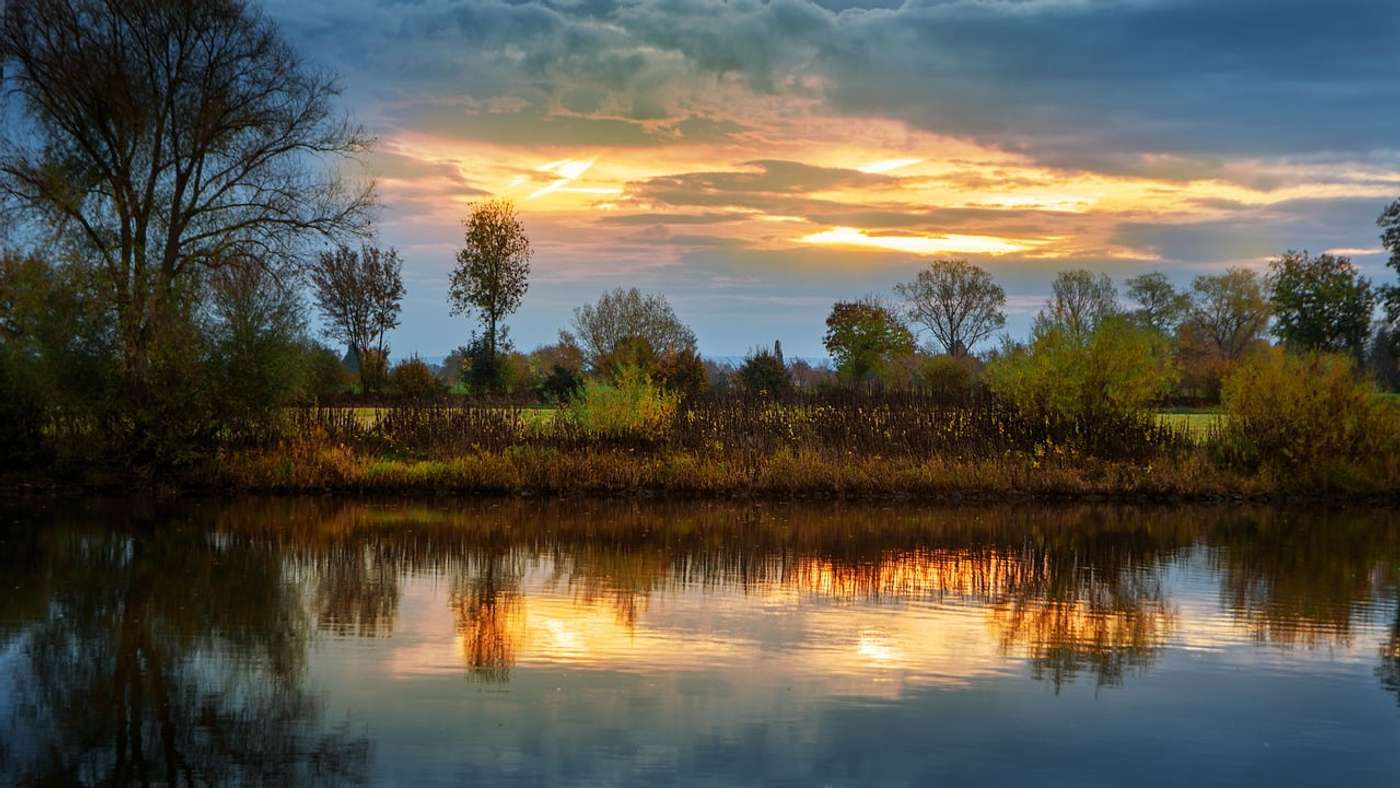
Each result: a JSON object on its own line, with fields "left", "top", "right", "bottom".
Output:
{"left": 212, "top": 445, "right": 1287, "bottom": 498}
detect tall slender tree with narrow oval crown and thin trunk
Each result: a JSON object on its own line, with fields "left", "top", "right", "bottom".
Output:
{"left": 448, "top": 199, "right": 532, "bottom": 364}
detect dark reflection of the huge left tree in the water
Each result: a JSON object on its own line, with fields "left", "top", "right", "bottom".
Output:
{"left": 0, "top": 511, "right": 368, "bottom": 784}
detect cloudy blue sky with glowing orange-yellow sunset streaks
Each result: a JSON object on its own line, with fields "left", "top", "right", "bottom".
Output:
{"left": 265, "top": 0, "right": 1400, "bottom": 357}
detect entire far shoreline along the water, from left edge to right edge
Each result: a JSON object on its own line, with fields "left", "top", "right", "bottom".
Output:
{"left": 8, "top": 446, "right": 1400, "bottom": 508}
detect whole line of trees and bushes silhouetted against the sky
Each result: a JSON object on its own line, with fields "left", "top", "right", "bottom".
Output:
{"left": 0, "top": 0, "right": 1400, "bottom": 467}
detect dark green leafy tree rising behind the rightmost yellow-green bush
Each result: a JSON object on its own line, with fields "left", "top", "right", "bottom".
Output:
{"left": 1268, "top": 252, "right": 1376, "bottom": 358}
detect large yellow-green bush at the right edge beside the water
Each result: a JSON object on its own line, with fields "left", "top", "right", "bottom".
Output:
{"left": 1214, "top": 347, "right": 1400, "bottom": 486}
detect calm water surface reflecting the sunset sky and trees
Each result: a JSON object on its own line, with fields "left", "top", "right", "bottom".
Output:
{"left": 0, "top": 500, "right": 1400, "bottom": 787}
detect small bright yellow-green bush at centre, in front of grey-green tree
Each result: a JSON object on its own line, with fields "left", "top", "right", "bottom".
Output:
{"left": 560, "top": 367, "right": 679, "bottom": 437}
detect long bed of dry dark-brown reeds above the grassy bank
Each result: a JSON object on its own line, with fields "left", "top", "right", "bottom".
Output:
{"left": 270, "top": 392, "right": 1194, "bottom": 462}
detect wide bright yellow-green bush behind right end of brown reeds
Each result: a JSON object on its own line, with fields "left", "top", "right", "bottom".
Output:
{"left": 986, "top": 318, "right": 1177, "bottom": 418}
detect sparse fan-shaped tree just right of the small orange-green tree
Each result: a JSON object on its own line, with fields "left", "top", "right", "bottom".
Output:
{"left": 895, "top": 259, "right": 1007, "bottom": 356}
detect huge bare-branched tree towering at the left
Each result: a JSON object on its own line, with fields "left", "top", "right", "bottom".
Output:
{"left": 0, "top": 0, "right": 372, "bottom": 395}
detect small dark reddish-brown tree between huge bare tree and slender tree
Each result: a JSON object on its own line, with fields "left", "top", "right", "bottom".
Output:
{"left": 309, "top": 245, "right": 405, "bottom": 386}
